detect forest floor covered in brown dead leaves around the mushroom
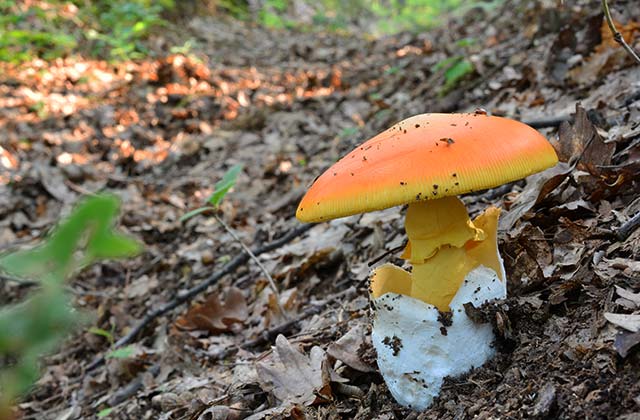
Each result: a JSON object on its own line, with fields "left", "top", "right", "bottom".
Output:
{"left": 0, "top": 1, "right": 640, "bottom": 419}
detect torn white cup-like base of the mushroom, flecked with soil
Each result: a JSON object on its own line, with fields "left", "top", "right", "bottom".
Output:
{"left": 371, "top": 266, "right": 507, "bottom": 410}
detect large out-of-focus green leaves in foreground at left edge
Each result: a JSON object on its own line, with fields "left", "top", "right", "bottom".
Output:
{"left": 0, "top": 195, "right": 142, "bottom": 417}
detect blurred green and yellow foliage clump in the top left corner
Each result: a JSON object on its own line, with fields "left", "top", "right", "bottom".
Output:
{"left": 0, "top": 0, "right": 173, "bottom": 63}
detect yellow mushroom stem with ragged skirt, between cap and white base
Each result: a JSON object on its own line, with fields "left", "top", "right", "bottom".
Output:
{"left": 371, "top": 197, "right": 504, "bottom": 312}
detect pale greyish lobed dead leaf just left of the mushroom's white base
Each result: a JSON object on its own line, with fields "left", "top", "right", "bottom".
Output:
{"left": 257, "top": 335, "right": 332, "bottom": 405}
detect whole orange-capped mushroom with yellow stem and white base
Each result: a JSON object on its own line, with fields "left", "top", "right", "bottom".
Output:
{"left": 296, "top": 113, "right": 558, "bottom": 410}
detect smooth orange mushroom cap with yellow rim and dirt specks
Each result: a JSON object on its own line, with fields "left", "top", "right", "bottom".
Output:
{"left": 296, "top": 114, "right": 558, "bottom": 222}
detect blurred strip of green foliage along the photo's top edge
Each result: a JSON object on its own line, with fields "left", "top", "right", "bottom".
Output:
{"left": 0, "top": 0, "right": 500, "bottom": 63}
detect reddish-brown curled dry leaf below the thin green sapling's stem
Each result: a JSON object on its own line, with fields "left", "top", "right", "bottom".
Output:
{"left": 176, "top": 287, "right": 249, "bottom": 334}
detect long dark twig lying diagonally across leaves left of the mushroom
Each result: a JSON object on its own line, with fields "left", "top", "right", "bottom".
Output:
{"left": 85, "top": 224, "right": 314, "bottom": 373}
